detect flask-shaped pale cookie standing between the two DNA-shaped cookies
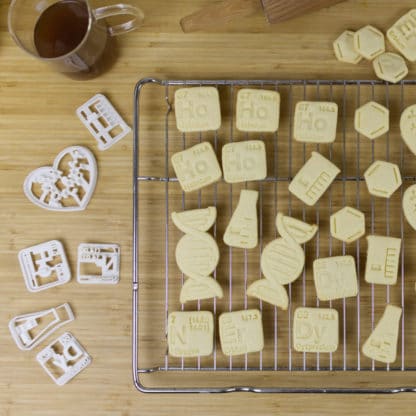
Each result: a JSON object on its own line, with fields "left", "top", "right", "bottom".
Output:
{"left": 224, "top": 189, "right": 259, "bottom": 248}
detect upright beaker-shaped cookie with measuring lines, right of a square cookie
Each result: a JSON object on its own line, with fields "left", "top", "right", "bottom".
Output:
{"left": 365, "top": 235, "right": 402, "bottom": 285}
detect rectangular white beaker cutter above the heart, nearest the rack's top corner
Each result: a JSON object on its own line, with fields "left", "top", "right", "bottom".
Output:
{"left": 76, "top": 94, "right": 131, "bottom": 150}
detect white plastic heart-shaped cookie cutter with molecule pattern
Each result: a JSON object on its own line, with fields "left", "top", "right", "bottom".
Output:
{"left": 23, "top": 146, "right": 97, "bottom": 211}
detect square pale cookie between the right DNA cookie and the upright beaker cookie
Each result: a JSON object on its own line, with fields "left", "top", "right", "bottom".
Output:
{"left": 313, "top": 256, "right": 358, "bottom": 300}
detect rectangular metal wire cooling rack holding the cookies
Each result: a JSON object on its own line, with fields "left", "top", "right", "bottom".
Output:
{"left": 132, "top": 78, "right": 416, "bottom": 393}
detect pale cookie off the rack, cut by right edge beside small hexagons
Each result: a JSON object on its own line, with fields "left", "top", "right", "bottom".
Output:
{"left": 387, "top": 9, "right": 416, "bottom": 62}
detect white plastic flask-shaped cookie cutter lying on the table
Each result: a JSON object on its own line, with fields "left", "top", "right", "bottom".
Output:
{"left": 9, "top": 303, "right": 74, "bottom": 351}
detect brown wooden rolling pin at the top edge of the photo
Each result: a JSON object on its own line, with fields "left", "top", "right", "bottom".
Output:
{"left": 180, "top": 0, "right": 343, "bottom": 32}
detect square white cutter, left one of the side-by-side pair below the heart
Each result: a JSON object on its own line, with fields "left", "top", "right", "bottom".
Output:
{"left": 18, "top": 240, "right": 71, "bottom": 292}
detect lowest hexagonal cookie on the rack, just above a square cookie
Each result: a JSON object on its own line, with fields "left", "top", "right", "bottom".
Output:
{"left": 330, "top": 207, "right": 365, "bottom": 243}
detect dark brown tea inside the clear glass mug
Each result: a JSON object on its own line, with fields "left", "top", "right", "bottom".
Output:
{"left": 34, "top": 0, "right": 115, "bottom": 79}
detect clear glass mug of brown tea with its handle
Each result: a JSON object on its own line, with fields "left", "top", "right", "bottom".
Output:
{"left": 8, "top": 0, "right": 144, "bottom": 78}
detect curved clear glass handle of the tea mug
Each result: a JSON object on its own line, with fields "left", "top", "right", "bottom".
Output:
{"left": 93, "top": 4, "right": 144, "bottom": 36}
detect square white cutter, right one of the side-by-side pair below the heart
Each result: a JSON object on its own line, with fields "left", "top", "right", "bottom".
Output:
{"left": 77, "top": 244, "right": 120, "bottom": 284}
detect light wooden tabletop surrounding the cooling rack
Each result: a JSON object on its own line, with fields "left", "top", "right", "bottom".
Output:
{"left": 0, "top": 0, "right": 416, "bottom": 416}
